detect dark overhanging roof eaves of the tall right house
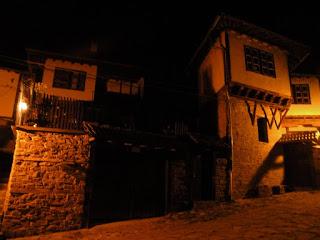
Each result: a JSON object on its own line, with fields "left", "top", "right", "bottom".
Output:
{"left": 187, "top": 14, "right": 310, "bottom": 70}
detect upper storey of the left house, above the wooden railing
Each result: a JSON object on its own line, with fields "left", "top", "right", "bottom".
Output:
{"left": 27, "top": 49, "right": 144, "bottom": 101}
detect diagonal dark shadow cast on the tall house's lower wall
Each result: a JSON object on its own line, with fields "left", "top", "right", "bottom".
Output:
{"left": 245, "top": 143, "right": 284, "bottom": 197}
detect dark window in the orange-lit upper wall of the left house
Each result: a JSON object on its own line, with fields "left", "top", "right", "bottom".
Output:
{"left": 53, "top": 68, "right": 87, "bottom": 91}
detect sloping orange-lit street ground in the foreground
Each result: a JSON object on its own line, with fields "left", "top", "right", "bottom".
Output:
{"left": 10, "top": 191, "right": 320, "bottom": 240}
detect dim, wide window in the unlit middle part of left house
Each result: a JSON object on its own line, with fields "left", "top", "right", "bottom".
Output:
{"left": 106, "top": 79, "right": 140, "bottom": 95}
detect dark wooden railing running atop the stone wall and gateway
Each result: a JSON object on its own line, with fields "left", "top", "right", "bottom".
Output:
{"left": 21, "top": 93, "right": 189, "bottom": 136}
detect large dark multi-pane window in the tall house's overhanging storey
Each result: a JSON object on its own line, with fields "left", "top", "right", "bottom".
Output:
{"left": 244, "top": 46, "right": 276, "bottom": 78}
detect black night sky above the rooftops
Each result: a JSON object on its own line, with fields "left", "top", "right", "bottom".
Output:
{"left": 0, "top": 0, "right": 320, "bottom": 75}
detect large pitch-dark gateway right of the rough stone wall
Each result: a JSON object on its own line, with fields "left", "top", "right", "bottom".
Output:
{"left": 89, "top": 143, "right": 166, "bottom": 224}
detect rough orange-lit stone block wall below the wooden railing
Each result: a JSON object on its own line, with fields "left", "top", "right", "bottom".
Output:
{"left": 2, "top": 130, "right": 90, "bottom": 237}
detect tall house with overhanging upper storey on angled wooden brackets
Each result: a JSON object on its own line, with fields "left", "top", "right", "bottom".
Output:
{"left": 191, "top": 15, "right": 308, "bottom": 198}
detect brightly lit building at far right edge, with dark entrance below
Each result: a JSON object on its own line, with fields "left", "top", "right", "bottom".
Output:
{"left": 280, "top": 74, "right": 320, "bottom": 187}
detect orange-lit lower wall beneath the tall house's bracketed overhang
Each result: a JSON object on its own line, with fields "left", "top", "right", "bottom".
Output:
{"left": 230, "top": 97, "right": 285, "bottom": 198}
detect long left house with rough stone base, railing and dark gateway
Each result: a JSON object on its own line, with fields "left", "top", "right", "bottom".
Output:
{"left": 1, "top": 49, "right": 197, "bottom": 237}
